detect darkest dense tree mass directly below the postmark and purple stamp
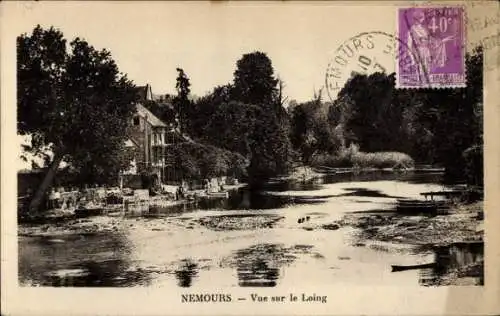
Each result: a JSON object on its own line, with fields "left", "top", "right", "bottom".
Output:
{"left": 322, "top": 48, "right": 483, "bottom": 182}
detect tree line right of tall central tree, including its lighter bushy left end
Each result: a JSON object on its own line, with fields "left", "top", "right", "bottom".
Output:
{"left": 291, "top": 47, "right": 483, "bottom": 185}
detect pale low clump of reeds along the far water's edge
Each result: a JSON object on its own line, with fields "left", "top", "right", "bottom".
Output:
{"left": 312, "top": 145, "right": 415, "bottom": 169}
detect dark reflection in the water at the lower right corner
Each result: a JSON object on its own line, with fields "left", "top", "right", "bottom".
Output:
{"left": 419, "top": 242, "right": 484, "bottom": 285}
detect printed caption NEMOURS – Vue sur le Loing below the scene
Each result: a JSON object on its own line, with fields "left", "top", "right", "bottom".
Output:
{"left": 181, "top": 293, "right": 328, "bottom": 303}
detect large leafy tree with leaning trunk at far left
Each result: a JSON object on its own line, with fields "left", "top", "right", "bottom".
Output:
{"left": 17, "top": 26, "right": 136, "bottom": 212}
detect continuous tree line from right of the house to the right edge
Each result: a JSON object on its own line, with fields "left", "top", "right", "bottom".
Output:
{"left": 146, "top": 48, "right": 483, "bottom": 184}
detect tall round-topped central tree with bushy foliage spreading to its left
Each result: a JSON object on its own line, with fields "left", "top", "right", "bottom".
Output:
{"left": 181, "top": 52, "right": 291, "bottom": 185}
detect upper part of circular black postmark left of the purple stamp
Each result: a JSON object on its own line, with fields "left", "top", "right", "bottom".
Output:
{"left": 325, "top": 32, "right": 425, "bottom": 101}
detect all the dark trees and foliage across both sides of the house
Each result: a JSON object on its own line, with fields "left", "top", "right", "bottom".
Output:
{"left": 17, "top": 22, "right": 483, "bottom": 210}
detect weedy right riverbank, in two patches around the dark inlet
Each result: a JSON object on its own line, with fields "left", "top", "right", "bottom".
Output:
{"left": 333, "top": 201, "right": 484, "bottom": 286}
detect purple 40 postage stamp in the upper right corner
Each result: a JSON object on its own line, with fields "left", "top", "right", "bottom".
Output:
{"left": 396, "top": 6, "right": 466, "bottom": 88}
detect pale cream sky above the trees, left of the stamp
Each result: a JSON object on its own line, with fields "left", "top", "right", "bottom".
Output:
{"left": 1, "top": 1, "right": 396, "bottom": 102}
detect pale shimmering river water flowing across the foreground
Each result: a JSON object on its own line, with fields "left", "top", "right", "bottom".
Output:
{"left": 19, "top": 172, "right": 482, "bottom": 288}
